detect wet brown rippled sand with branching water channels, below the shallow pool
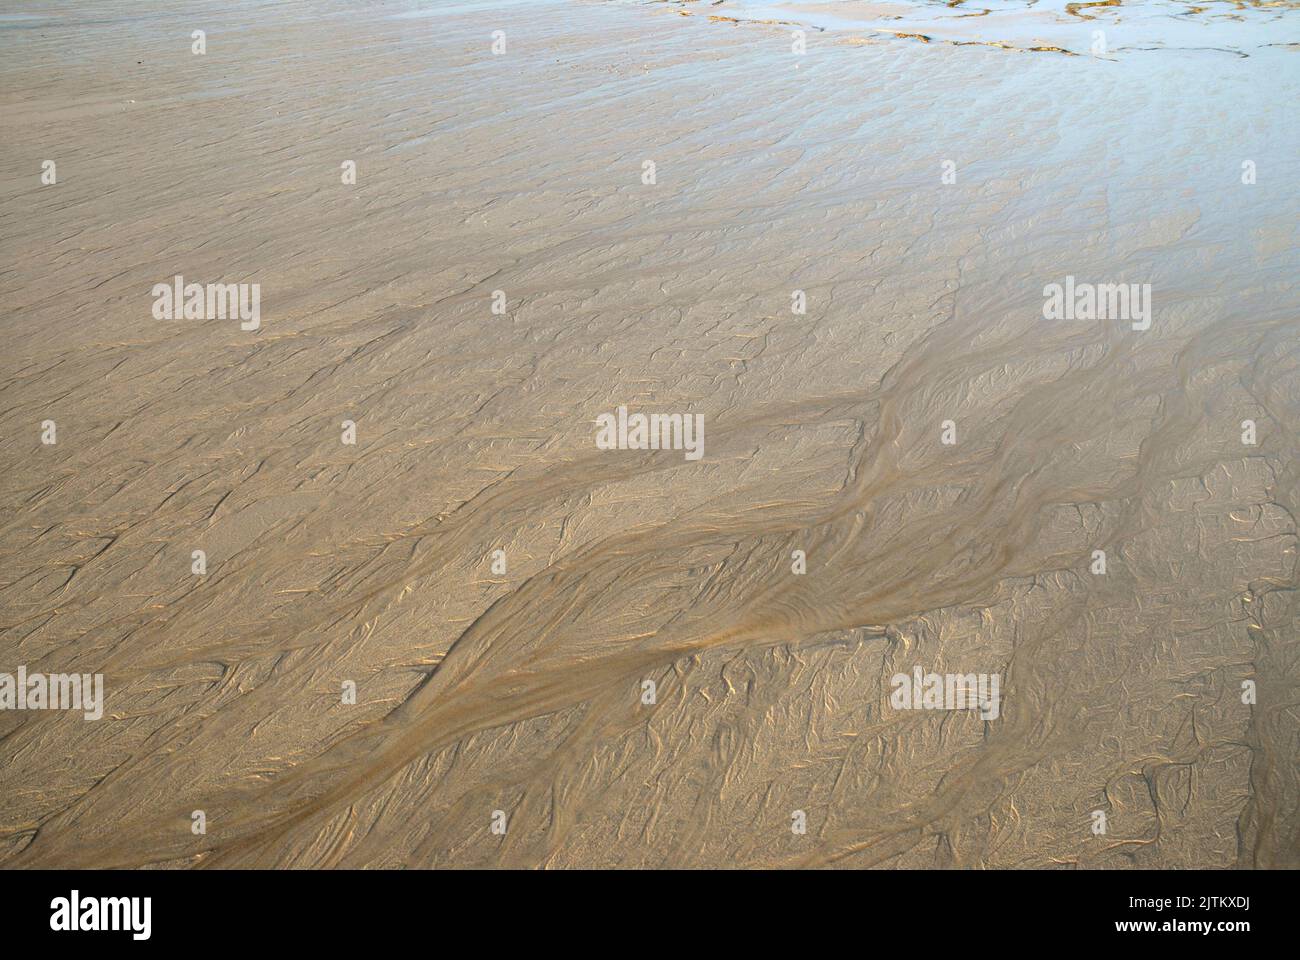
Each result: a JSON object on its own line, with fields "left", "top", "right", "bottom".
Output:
{"left": 0, "top": 0, "right": 1300, "bottom": 868}
